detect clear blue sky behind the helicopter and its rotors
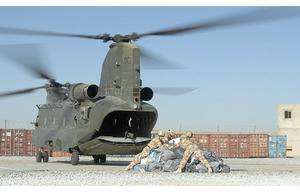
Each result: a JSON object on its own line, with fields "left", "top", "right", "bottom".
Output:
{"left": 0, "top": 7, "right": 300, "bottom": 131}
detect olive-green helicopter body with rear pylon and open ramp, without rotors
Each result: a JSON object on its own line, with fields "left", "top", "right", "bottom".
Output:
{"left": 32, "top": 43, "right": 157, "bottom": 155}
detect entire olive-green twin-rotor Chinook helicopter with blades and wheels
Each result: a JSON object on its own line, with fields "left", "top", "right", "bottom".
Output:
{"left": 0, "top": 8, "right": 300, "bottom": 165}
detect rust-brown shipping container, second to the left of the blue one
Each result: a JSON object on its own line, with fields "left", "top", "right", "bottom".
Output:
{"left": 229, "top": 134, "right": 249, "bottom": 158}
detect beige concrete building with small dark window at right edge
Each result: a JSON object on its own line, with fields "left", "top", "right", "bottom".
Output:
{"left": 278, "top": 104, "right": 300, "bottom": 156}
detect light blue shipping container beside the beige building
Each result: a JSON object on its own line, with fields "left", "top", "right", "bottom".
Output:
{"left": 269, "top": 135, "right": 286, "bottom": 158}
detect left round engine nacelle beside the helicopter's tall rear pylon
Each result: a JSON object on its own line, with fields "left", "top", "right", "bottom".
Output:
{"left": 69, "top": 83, "right": 99, "bottom": 101}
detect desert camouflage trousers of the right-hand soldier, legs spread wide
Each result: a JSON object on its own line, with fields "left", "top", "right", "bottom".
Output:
{"left": 178, "top": 144, "right": 211, "bottom": 169}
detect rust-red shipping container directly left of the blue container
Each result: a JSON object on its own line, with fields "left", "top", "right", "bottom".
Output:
{"left": 249, "top": 134, "right": 268, "bottom": 157}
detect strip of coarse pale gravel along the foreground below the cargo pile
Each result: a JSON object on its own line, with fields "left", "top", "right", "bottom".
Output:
{"left": 0, "top": 171, "right": 300, "bottom": 186}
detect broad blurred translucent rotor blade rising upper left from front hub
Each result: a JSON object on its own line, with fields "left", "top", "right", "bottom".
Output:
{"left": 0, "top": 44, "right": 52, "bottom": 80}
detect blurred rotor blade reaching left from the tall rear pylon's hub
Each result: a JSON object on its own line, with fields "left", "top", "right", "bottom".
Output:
{"left": 0, "top": 27, "right": 102, "bottom": 39}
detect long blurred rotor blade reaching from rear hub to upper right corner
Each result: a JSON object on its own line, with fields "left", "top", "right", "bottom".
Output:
{"left": 136, "top": 7, "right": 300, "bottom": 38}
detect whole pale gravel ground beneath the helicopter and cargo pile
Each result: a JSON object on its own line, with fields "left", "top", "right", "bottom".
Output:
{"left": 0, "top": 156, "right": 300, "bottom": 187}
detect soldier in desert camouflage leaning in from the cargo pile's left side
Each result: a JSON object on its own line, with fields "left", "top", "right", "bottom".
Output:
{"left": 125, "top": 131, "right": 165, "bottom": 171}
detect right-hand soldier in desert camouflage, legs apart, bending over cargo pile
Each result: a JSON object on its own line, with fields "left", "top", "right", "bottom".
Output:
{"left": 169, "top": 135, "right": 212, "bottom": 173}
